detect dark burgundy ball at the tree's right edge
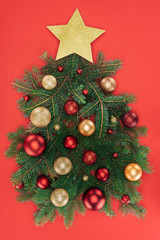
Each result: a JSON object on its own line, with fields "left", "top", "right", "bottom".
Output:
{"left": 122, "top": 111, "right": 138, "bottom": 128}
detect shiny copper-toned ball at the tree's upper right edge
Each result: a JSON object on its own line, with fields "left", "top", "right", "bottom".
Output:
{"left": 100, "top": 77, "right": 116, "bottom": 94}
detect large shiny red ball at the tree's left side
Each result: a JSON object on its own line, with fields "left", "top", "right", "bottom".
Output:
{"left": 23, "top": 134, "right": 46, "bottom": 157}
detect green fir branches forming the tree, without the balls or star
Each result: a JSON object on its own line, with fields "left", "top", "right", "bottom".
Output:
{"left": 6, "top": 52, "right": 151, "bottom": 227}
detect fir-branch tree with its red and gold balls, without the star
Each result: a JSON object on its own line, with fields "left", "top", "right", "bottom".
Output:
{"left": 6, "top": 11, "right": 151, "bottom": 228}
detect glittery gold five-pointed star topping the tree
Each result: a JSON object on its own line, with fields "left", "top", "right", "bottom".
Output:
{"left": 47, "top": 9, "right": 105, "bottom": 62}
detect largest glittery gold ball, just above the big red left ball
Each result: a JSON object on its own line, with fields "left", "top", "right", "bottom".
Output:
{"left": 30, "top": 107, "right": 51, "bottom": 127}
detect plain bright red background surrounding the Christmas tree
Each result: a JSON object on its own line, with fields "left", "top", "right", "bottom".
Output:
{"left": 0, "top": 0, "right": 160, "bottom": 240}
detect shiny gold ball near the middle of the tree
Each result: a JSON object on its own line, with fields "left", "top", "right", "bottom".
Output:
{"left": 78, "top": 119, "right": 95, "bottom": 137}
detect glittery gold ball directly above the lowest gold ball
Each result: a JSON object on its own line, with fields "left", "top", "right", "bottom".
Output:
{"left": 54, "top": 157, "right": 72, "bottom": 175}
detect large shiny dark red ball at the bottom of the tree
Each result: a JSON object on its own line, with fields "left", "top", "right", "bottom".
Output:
{"left": 83, "top": 187, "right": 106, "bottom": 211}
